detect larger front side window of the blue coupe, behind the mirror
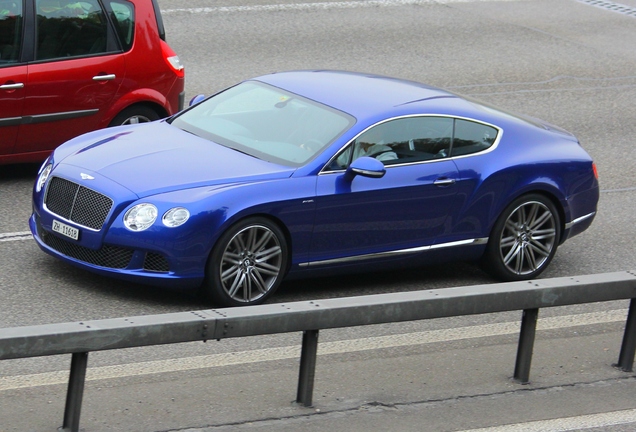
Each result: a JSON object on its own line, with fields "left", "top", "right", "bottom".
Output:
{"left": 329, "top": 116, "right": 453, "bottom": 170}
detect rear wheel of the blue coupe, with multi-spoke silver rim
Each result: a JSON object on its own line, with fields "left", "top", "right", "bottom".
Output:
{"left": 482, "top": 194, "right": 561, "bottom": 281}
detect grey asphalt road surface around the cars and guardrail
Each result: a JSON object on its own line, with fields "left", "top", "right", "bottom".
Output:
{"left": 0, "top": 0, "right": 636, "bottom": 432}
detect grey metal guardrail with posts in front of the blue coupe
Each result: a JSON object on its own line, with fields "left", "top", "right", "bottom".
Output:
{"left": 0, "top": 271, "right": 636, "bottom": 432}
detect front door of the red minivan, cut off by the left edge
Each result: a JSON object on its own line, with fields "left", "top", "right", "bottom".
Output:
{"left": 0, "top": 0, "right": 27, "bottom": 158}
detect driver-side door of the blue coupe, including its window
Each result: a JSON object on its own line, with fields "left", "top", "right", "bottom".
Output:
{"left": 310, "top": 117, "right": 458, "bottom": 264}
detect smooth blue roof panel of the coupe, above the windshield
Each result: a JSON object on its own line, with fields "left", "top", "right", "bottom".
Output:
{"left": 255, "top": 70, "right": 458, "bottom": 119}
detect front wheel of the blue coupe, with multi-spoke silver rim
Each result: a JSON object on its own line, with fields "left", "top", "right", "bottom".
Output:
{"left": 202, "top": 217, "right": 288, "bottom": 306}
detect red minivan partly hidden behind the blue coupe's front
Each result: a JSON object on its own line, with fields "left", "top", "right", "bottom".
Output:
{"left": 0, "top": 0, "right": 185, "bottom": 164}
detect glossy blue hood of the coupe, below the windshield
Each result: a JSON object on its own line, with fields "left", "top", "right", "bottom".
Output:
{"left": 56, "top": 122, "right": 294, "bottom": 198}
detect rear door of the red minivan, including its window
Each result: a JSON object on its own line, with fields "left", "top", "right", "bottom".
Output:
{"left": 15, "top": 0, "right": 125, "bottom": 153}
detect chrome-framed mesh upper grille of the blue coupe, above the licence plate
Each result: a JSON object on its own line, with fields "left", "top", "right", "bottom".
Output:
{"left": 44, "top": 177, "right": 113, "bottom": 230}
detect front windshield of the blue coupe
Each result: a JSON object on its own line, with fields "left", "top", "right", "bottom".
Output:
{"left": 172, "top": 81, "right": 354, "bottom": 166}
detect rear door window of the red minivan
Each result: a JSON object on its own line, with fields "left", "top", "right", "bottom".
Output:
{"left": 35, "top": 0, "right": 107, "bottom": 60}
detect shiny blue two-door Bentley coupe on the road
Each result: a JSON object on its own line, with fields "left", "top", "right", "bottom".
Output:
{"left": 30, "top": 71, "right": 599, "bottom": 306}
